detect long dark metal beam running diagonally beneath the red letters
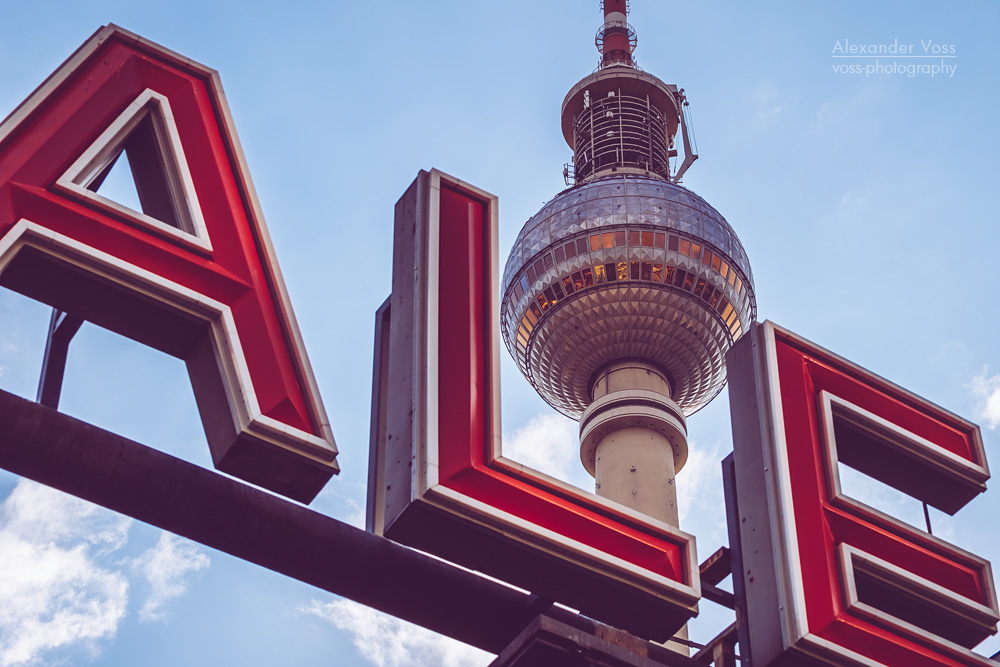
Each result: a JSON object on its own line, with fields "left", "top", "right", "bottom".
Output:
{"left": 0, "top": 390, "right": 698, "bottom": 667}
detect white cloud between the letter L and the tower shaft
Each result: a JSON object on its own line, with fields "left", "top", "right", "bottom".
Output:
{"left": 503, "top": 414, "right": 590, "bottom": 485}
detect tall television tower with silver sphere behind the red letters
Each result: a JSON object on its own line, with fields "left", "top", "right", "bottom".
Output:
{"left": 501, "top": 0, "right": 756, "bottom": 526}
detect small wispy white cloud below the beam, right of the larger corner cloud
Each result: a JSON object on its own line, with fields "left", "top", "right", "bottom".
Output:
{"left": 138, "top": 532, "right": 211, "bottom": 621}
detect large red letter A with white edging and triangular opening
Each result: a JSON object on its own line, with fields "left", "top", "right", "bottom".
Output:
{"left": 0, "top": 26, "right": 338, "bottom": 502}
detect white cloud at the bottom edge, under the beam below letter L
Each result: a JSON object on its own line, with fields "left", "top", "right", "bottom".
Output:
{"left": 301, "top": 600, "right": 494, "bottom": 667}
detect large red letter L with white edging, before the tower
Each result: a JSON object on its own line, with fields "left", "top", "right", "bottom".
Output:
{"left": 369, "top": 171, "right": 700, "bottom": 639}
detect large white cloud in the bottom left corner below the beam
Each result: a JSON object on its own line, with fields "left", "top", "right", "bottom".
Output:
{"left": 0, "top": 480, "right": 131, "bottom": 666}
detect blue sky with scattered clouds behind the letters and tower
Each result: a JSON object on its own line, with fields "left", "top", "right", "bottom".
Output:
{"left": 0, "top": 0, "right": 1000, "bottom": 667}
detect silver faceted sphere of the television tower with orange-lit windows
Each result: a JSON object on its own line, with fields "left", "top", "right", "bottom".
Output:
{"left": 501, "top": 173, "right": 756, "bottom": 419}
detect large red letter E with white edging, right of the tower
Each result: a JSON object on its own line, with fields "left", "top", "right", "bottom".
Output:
{"left": 727, "top": 322, "right": 1000, "bottom": 667}
